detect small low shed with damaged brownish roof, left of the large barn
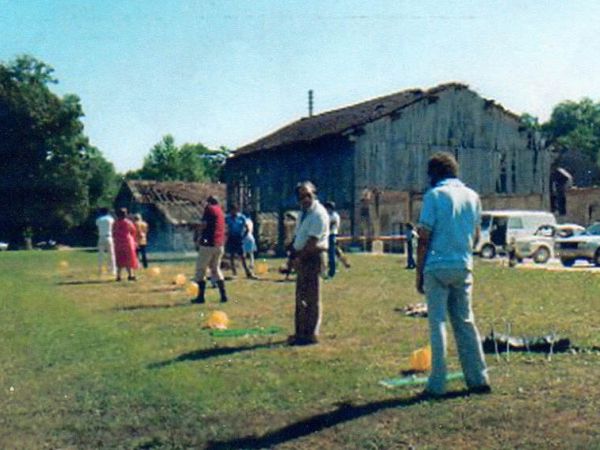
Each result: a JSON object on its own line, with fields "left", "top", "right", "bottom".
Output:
{"left": 114, "top": 180, "right": 225, "bottom": 252}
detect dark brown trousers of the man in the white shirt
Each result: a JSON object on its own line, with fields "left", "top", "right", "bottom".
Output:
{"left": 295, "top": 253, "right": 323, "bottom": 339}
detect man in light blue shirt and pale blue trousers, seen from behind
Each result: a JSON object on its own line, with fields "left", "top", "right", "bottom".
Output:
{"left": 416, "top": 153, "right": 491, "bottom": 396}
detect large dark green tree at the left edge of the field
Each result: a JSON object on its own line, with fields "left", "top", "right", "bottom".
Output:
{"left": 0, "top": 56, "right": 114, "bottom": 247}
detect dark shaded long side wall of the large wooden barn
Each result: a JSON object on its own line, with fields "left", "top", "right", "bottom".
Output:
{"left": 224, "top": 136, "right": 354, "bottom": 253}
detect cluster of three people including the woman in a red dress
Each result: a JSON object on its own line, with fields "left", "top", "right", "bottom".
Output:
{"left": 96, "top": 208, "right": 148, "bottom": 281}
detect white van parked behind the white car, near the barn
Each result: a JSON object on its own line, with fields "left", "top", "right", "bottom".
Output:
{"left": 475, "top": 209, "right": 556, "bottom": 258}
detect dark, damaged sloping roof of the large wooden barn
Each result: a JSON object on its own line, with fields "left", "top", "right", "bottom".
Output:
{"left": 233, "top": 83, "right": 518, "bottom": 158}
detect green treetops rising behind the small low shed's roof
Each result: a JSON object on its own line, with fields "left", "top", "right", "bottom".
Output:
{"left": 126, "top": 134, "right": 230, "bottom": 182}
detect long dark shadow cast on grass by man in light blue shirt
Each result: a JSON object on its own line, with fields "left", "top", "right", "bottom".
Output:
{"left": 205, "top": 389, "right": 469, "bottom": 450}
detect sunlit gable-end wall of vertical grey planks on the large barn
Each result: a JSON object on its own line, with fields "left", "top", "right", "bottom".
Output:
{"left": 353, "top": 89, "right": 551, "bottom": 211}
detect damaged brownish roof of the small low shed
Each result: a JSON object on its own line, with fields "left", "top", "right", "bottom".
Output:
{"left": 124, "top": 180, "right": 226, "bottom": 225}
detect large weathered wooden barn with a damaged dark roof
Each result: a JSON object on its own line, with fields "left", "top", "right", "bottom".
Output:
{"left": 225, "top": 83, "right": 552, "bottom": 248}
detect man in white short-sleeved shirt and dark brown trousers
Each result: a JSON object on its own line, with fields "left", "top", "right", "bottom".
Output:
{"left": 288, "top": 181, "right": 329, "bottom": 345}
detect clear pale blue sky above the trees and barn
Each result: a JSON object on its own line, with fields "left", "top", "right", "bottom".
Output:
{"left": 0, "top": 0, "right": 600, "bottom": 171}
